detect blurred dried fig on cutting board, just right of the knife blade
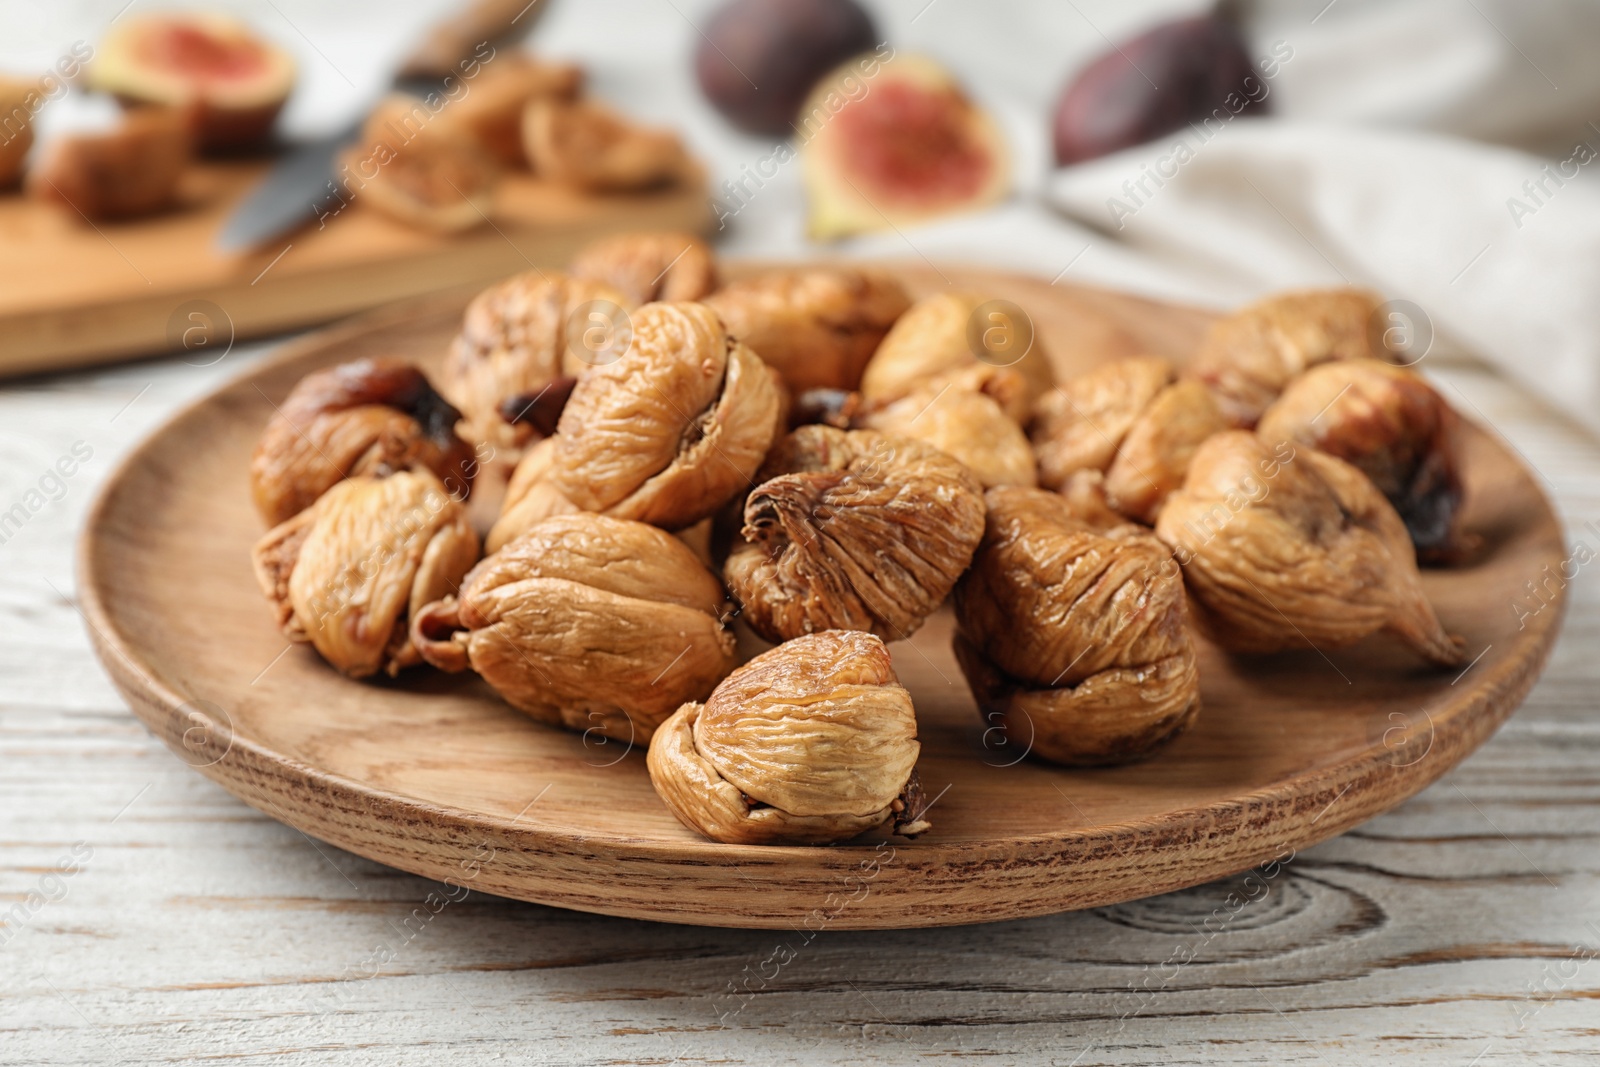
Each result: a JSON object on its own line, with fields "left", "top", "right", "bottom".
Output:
{"left": 339, "top": 93, "right": 498, "bottom": 234}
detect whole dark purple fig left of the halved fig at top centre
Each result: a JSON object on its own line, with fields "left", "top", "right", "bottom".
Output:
{"left": 694, "top": 0, "right": 880, "bottom": 136}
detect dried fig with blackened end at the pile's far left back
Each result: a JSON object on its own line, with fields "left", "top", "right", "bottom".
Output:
{"left": 250, "top": 358, "right": 477, "bottom": 525}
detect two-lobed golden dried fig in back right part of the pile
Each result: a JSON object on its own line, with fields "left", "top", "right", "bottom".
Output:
{"left": 1032, "top": 357, "right": 1227, "bottom": 525}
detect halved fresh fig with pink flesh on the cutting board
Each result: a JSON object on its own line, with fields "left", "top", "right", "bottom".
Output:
{"left": 88, "top": 11, "right": 294, "bottom": 152}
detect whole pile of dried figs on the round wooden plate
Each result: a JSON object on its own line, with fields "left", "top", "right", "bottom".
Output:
{"left": 251, "top": 241, "right": 1475, "bottom": 845}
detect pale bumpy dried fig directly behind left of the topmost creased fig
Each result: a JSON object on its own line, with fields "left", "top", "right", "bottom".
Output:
{"left": 438, "top": 270, "right": 630, "bottom": 454}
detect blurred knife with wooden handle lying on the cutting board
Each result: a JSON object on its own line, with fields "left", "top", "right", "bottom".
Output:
{"left": 216, "top": 0, "right": 549, "bottom": 254}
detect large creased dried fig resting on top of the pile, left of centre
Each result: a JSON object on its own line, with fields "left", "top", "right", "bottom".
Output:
{"left": 549, "top": 304, "right": 782, "bottom": 530}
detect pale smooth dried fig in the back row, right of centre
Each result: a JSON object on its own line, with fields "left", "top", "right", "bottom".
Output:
{"left": 861, "top": 293, "right": 1056, "bottom": 427}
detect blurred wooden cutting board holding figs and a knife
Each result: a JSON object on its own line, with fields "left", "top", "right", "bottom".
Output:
{"left": 0, "top": 162, "right": 710, "bottom": 374}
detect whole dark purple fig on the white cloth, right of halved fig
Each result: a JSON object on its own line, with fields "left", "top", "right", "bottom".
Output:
{"left": 1054, "top": 16, "right": 1266, "bottom": 166}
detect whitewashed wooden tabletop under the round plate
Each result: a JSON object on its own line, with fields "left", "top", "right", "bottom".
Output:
{"left": 0, "top": 335, "right": 1600, "bottom": 1067}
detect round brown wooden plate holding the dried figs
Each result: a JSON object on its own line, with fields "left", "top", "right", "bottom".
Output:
{"left": 80, "top": 266, "right": 1563, "bottom": 929}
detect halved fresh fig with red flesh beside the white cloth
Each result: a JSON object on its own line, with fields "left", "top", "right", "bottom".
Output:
{"left": 797, "top": 56, "right": 1010, "bottom": 240}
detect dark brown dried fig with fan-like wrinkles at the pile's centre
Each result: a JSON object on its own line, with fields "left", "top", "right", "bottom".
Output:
{"left": 723, "top": 426, "right": 984, "bottom": 641}
